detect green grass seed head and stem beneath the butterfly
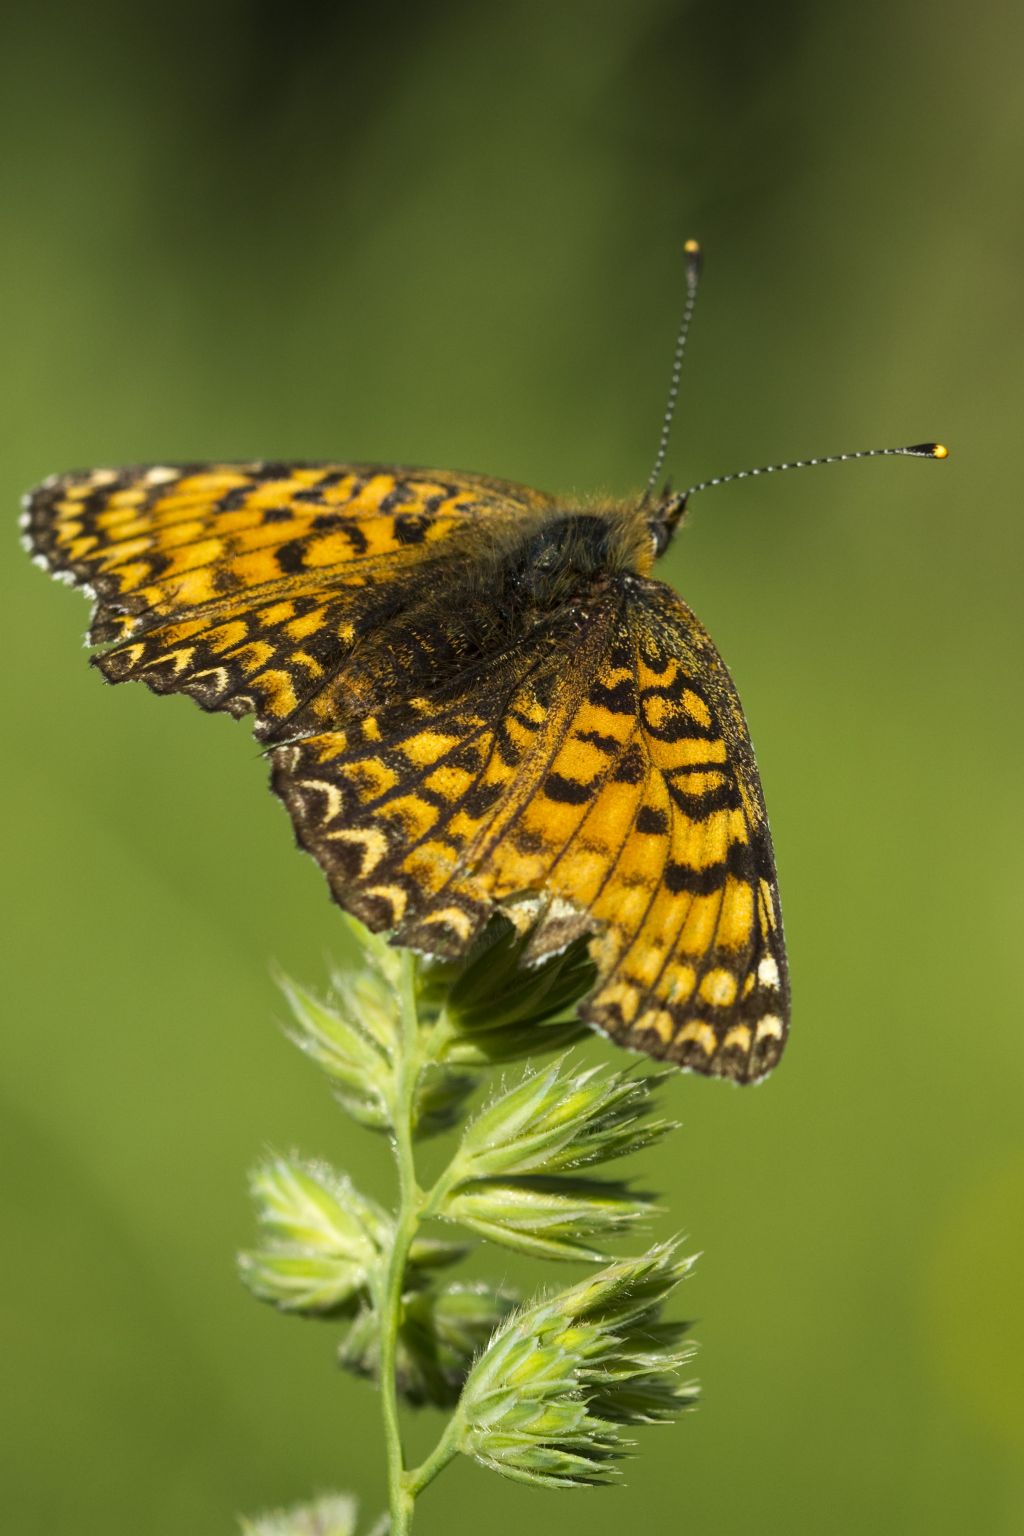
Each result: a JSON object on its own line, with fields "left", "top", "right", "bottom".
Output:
{"left": 239, "top": 919, "right": 694, "bottom": 1536}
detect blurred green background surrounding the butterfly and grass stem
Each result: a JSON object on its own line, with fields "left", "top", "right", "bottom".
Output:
{"left": 0, "top": 0, "right": 1024, "bottom": 1536}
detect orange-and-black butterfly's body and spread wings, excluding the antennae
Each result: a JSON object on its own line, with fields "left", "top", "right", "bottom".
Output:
{"left": 23, "top": 462, "right": 789, "bottom": 1083}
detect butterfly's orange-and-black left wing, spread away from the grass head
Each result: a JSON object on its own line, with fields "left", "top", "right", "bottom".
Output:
{"left": 23, "top": 462, "right": 551, "bottom": 737}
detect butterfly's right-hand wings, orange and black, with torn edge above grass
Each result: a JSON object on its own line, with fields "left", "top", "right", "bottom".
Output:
{"left": 273, "top": 576, "right": 789, "bottom": 1081}
